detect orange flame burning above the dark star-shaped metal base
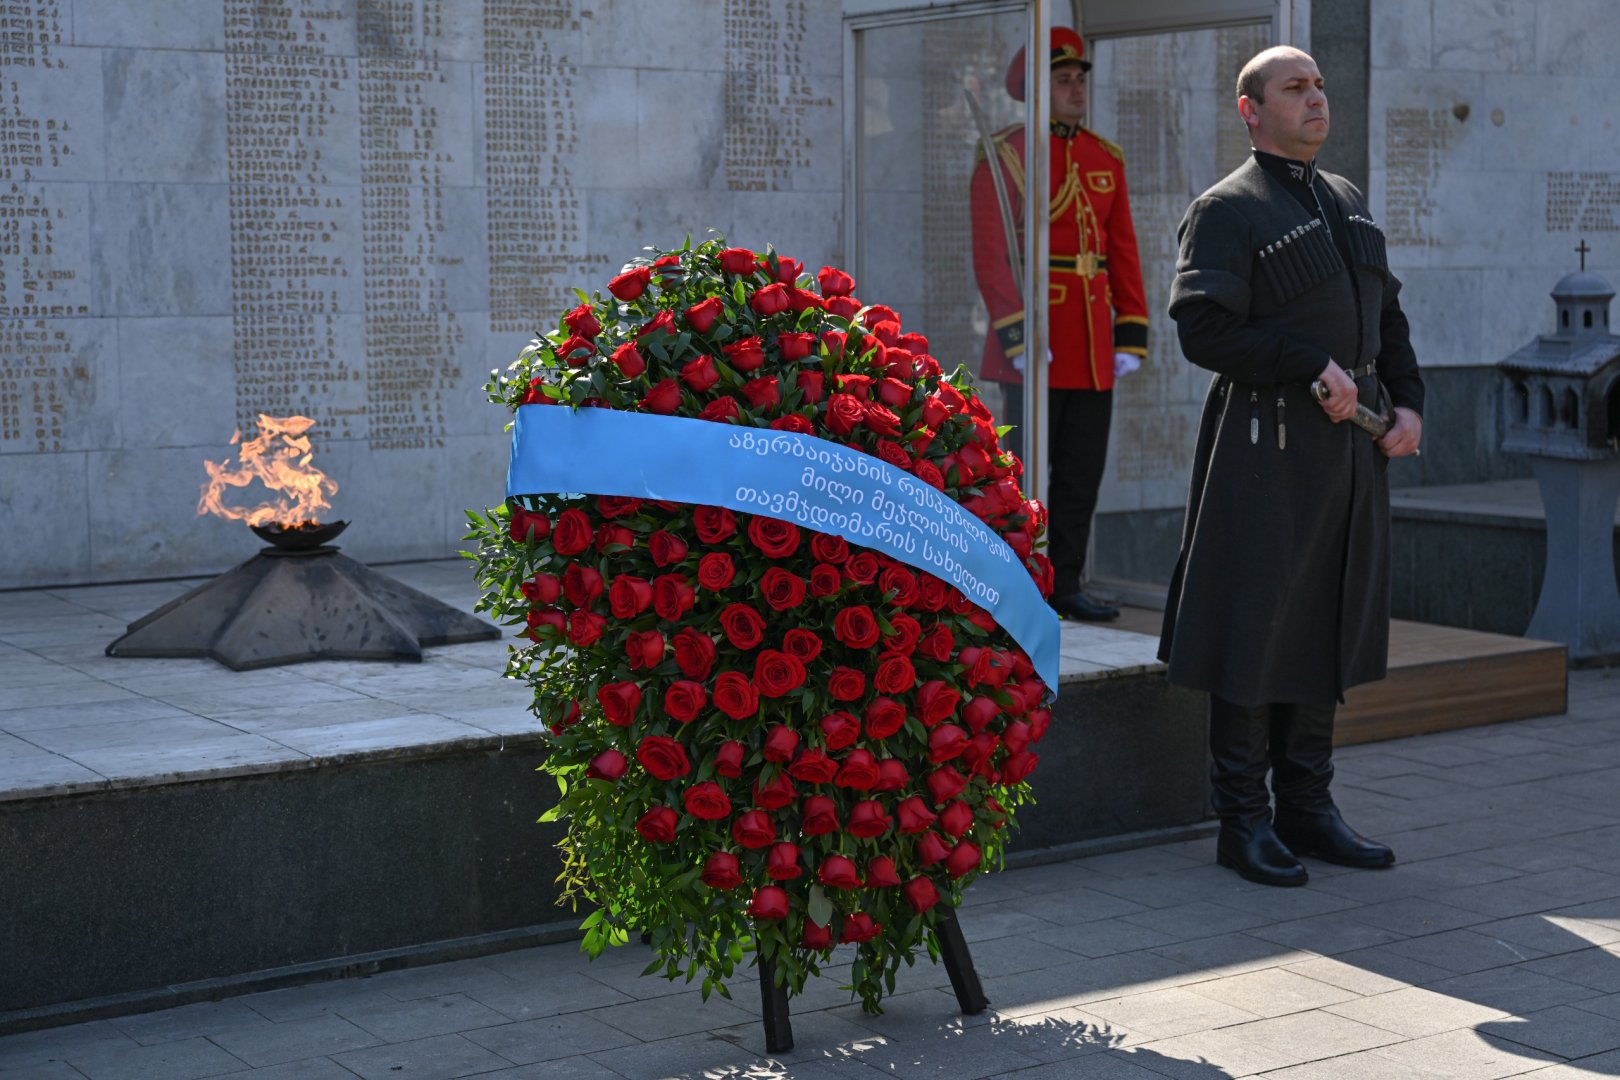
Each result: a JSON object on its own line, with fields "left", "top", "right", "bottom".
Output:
{"left": 198, "top": 413, "right": 337, "bottom": 528}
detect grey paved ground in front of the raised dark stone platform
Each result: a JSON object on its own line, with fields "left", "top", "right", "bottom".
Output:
{"left": 0, "top": 670, "right": 1620, "bottom": 1080}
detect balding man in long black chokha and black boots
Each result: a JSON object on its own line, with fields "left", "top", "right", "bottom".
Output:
{"left": 1158, "top": 47, "right": 1424, "bottom": 886}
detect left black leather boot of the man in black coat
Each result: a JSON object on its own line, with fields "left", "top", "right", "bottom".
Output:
{"left": 1210, "top": 695, "right": 1306, "bottom": 886}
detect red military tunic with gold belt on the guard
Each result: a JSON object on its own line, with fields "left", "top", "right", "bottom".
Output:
{"left": 972, "top": 121, "right": 1147, "bottom": 390}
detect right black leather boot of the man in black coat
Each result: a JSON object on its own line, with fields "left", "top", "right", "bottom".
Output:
{"left": 1270, "top": 704, "right": 1395, "bottom": 870}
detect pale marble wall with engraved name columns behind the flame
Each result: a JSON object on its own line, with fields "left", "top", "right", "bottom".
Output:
{"left": 0, "top": 0, "right": 842, "bottom": 588}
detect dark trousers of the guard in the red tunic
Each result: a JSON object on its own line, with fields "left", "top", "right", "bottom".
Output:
{"left": 1000, "top": 382, "right": 1113, "bottom": 596}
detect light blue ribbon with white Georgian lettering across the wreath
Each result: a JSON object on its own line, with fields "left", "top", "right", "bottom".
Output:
{"left": 507, "top": 405, "right": 1058, "bottom": 693}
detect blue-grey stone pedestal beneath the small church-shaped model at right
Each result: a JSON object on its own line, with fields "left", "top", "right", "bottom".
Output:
{"left": 1524, "top": 457, "right": 1620, "bottom": 665}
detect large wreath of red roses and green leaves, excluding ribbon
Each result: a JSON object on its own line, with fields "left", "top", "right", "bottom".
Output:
{"left": 470, "top": 240, "right": 1051, "bottom": 1010}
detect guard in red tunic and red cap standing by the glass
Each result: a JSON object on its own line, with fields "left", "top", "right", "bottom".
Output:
{"left": 972, "top": 26, "right": 1147, "bottom": 620}
